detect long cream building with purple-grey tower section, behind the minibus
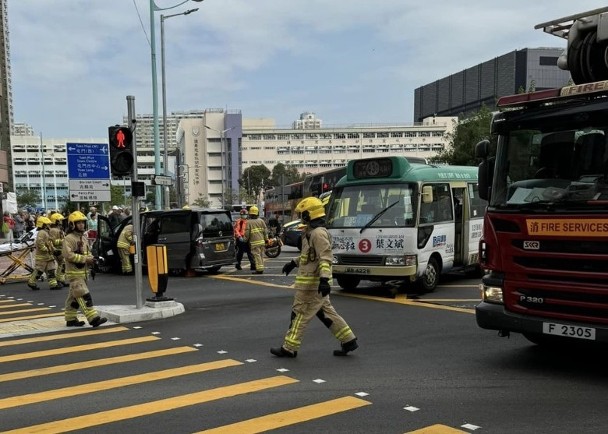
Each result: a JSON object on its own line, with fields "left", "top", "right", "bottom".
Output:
{"left": 177, "top": 109, "right": 457, "bottom": 207}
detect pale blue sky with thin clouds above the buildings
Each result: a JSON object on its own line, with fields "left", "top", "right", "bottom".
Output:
{"left": 8, "top": 0, "right": 605, "bottom": 138}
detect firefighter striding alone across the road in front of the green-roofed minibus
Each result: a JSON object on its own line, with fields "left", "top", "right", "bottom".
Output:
{"left": 270, "top": 197, "right": 359, "bottom": 357}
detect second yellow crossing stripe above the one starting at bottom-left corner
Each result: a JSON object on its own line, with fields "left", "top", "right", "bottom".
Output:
{"left": 0, "top": 347, "right": 198, "bottom": 383}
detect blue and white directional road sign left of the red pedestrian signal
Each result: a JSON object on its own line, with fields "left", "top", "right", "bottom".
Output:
{"left": 66, "top": 143, "right": 110, "bottom": 202}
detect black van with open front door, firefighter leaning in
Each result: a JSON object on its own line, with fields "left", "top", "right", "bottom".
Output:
{"left": 93, "top": 208, "right": 236, "bottom": 273}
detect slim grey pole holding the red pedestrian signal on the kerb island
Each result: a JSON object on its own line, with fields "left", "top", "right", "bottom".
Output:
{"left": 127, "top": 95, "right": 144, "bottom": 309}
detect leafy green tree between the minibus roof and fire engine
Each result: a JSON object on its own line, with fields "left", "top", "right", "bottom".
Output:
{"left": 431, "top": 106, "right": 495, "bottom": 166}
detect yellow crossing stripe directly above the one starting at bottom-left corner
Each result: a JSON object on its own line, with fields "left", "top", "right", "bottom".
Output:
{"left": 0, "top": 359, "right": 243, "bottom": 410}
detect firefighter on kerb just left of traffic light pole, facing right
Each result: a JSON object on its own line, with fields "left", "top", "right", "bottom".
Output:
{"left": 62, "top": 211, "right": 108, "bottom": 327}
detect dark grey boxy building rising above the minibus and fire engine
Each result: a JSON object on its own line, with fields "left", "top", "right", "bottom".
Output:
{"left": 414, "top": 48, "right": 570, "bottom": 122}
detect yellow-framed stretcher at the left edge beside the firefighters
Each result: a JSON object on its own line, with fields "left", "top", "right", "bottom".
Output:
{"left": 0, "top": 231, "right": 36, "bottom": 285}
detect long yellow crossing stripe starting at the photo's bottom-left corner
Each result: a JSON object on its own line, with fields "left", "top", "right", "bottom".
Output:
{"left": 4, "top": 375, "right": 298, "bottom": 434}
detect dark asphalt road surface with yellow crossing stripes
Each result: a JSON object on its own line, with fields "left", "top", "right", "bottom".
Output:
{"left": 0, "top": 248, "right": 608, "bottom": 433}
